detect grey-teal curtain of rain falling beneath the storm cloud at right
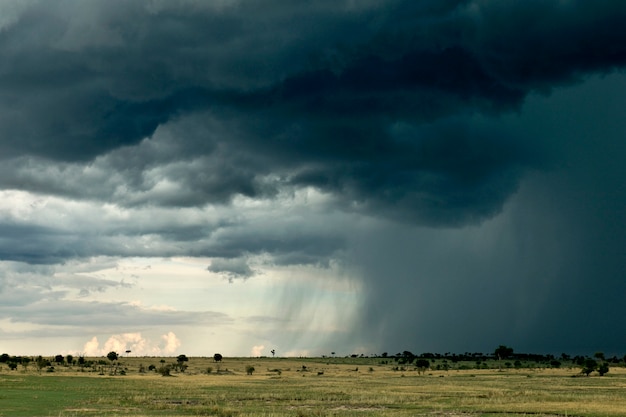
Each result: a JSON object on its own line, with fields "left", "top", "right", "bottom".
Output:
{"left": 347, "top": 75, "right": 626, "bottom": 355}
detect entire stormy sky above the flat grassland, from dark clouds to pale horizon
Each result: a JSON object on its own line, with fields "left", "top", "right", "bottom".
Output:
{"left": 0, "top": 0, "right": 626, "bottom": 356}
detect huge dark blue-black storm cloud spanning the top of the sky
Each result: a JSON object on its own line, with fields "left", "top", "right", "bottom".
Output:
{"left": 0, "top": 1, "right": 626, "bottom": 228}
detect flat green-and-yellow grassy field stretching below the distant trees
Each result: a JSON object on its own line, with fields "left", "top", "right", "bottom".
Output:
{"left": 0, "top": 357, "right": 626, "bottom": 417}
